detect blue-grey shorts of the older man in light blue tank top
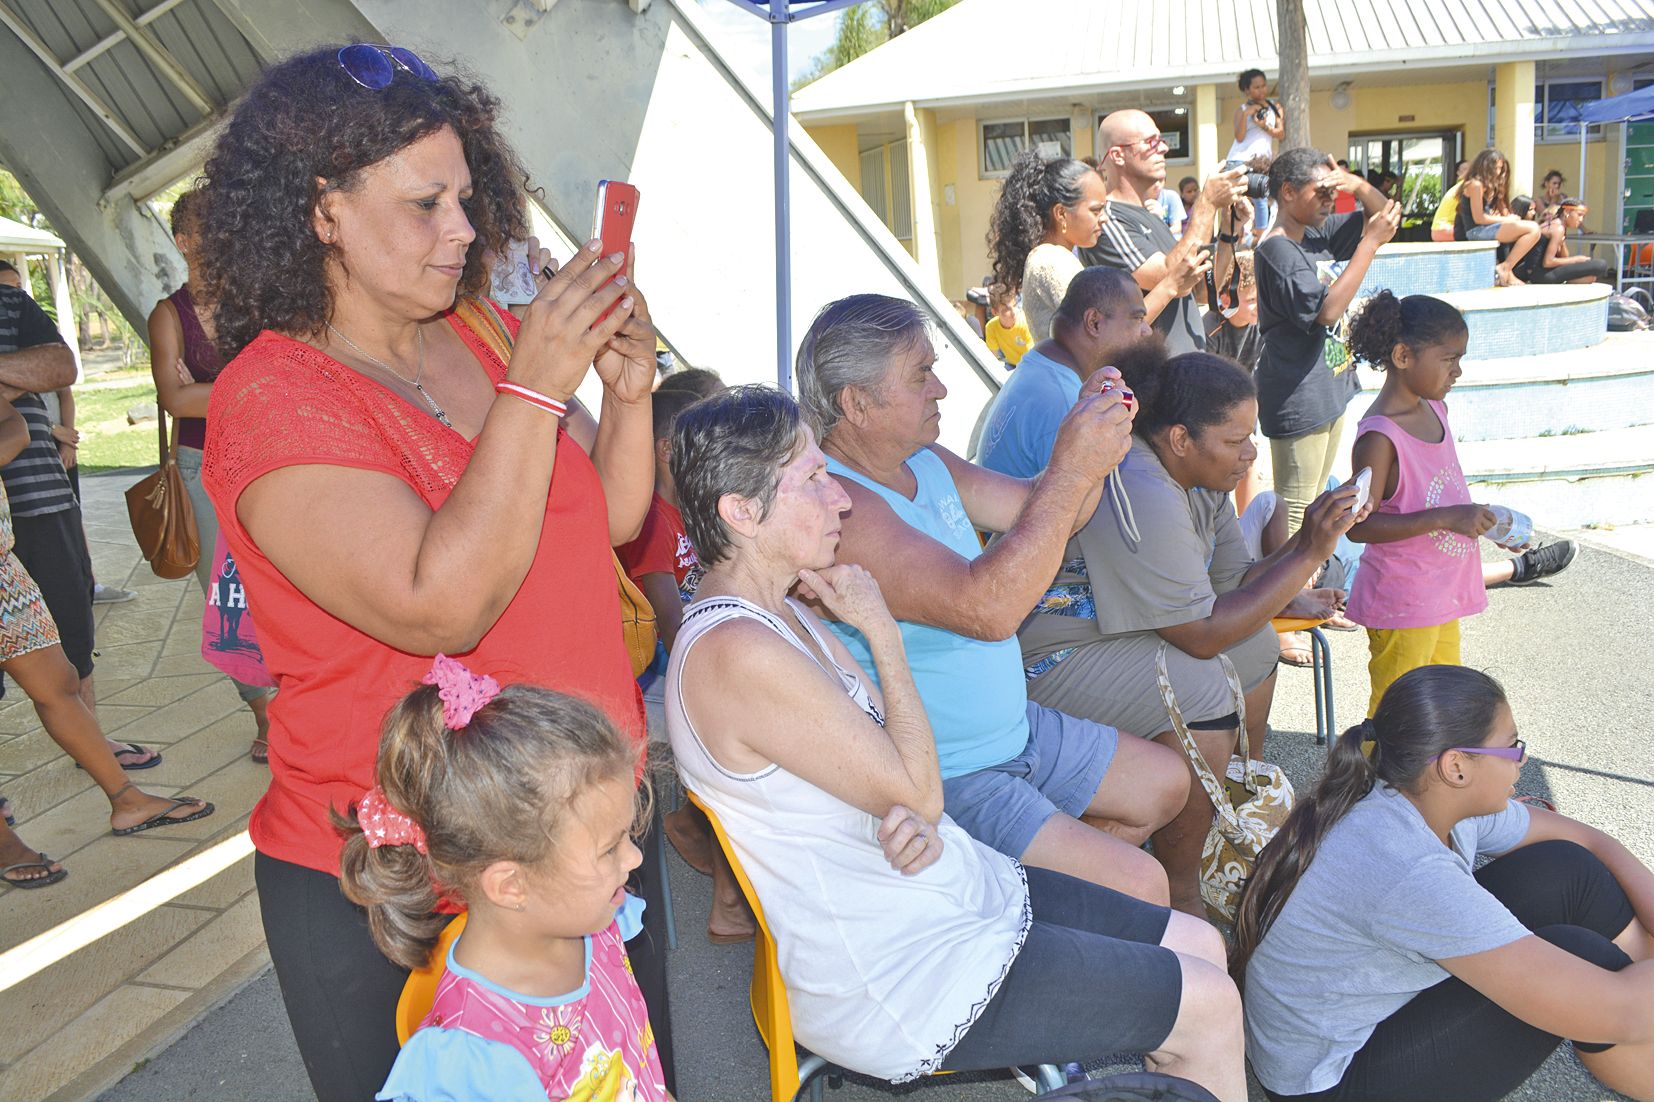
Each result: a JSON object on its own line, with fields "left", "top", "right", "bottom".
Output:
{"left": 941, "top": 702, "right": 1120, "bottom": 859}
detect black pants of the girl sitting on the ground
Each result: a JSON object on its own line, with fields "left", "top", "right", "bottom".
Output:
{"left": 1267, "top": 842, "right": 1636, "bottom": 1102}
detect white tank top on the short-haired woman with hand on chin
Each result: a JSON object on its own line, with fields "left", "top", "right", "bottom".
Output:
{"left": 667, "top": 597, "right": 1032, "bottom": 1082}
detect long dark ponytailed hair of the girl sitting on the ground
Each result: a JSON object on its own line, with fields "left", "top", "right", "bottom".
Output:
{"left": 1229, "top": 665, "right": 1505, "bottom": 983}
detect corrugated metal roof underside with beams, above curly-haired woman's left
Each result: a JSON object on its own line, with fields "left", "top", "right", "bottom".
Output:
{"left": 0, "top": 0, "right": 260, "bottom": 177}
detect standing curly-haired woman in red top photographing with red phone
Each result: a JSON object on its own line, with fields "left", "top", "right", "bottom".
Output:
{"left": 200, "top": 43, "right": 654, "bottom": 1102}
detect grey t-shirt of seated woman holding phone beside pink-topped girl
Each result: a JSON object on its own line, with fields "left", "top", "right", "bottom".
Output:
{"left": 1017, "top": 437, "right": 1252, "bottom": 662}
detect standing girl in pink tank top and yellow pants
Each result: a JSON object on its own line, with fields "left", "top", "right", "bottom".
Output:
{"left": 1350, "top": 291, "right": 1494, "bottom": 716}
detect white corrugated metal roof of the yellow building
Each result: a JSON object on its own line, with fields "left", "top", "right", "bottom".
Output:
{"left": 792, "top": 0, "right": 1654, "bottom": 117}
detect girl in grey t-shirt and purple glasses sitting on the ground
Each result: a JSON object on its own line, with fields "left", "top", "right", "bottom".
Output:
{"left": 1232, "top": 661, "right": 1654, "bottom": 1102}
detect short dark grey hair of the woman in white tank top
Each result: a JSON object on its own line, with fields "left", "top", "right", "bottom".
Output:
{"left": 672, "top": 384, "right": 804, "bottom": 566}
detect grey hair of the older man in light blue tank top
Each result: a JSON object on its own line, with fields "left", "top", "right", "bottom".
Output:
{"left": 796, "top": 295, "right": 928, "bottom": 442}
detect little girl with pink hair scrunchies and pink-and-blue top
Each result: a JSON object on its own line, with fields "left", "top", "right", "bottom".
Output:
{"left": 339, "top": 655, "right": 670, "bottom": 1102}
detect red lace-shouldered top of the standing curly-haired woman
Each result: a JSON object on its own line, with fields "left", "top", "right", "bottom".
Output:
{"left": 202, "top": 301, "right": 643, "bottom": 875}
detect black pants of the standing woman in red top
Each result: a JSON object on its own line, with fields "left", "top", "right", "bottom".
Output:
{"left": 253, "top": 819, "right": 675, "bottom": 1102}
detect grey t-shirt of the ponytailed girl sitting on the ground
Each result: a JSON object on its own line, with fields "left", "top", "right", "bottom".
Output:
{"left": 1245, "top": 784, "right": 1528, "bottom": 1094}
